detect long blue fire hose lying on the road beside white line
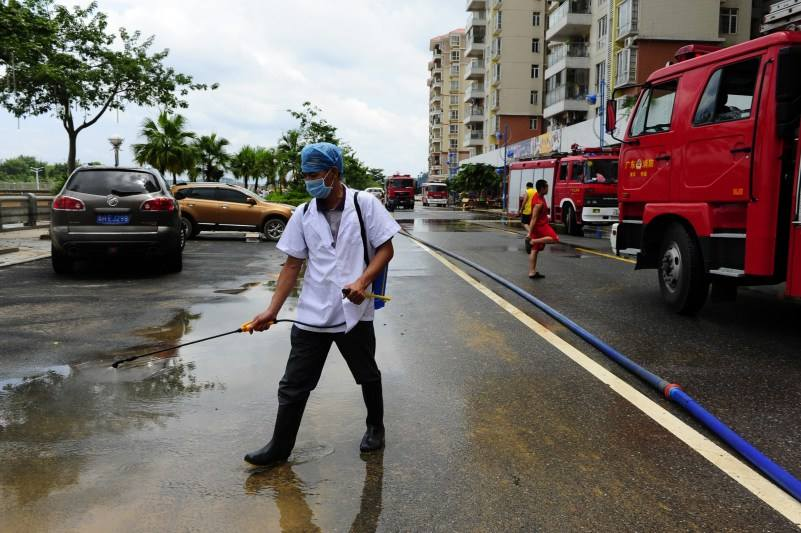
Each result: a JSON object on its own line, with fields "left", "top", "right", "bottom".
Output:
{"left": 403, "top": 231, "right": 801, "bottom": 502}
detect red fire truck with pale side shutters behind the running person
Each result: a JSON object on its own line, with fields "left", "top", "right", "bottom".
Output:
{"left": 507, "top": 148, "right": 618, "bottom": 235}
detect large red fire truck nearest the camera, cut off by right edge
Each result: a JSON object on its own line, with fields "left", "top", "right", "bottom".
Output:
{"left": 607, "top": 29, "right": 801, "bottom": 313}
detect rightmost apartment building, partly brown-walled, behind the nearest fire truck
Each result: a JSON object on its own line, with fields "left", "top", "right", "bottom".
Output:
{"left": 543, "top": 0, "right": 760, "bottom": 130}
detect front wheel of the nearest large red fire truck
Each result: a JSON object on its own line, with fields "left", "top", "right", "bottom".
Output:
{"left": 658, "top": 224, "right": 709, "bottom": 314}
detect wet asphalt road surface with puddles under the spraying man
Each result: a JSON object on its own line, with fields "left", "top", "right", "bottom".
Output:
{"left": 0, "top": 209, "right": 801, "bottom": 531}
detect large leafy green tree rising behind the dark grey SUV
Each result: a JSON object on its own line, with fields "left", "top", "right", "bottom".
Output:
{"left": 0, "top": 0, "right": 217, "bottom": 172}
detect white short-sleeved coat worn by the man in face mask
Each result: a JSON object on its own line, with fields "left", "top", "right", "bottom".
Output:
{"left": 278, "top": 187, "right": 400, "bottom": 332}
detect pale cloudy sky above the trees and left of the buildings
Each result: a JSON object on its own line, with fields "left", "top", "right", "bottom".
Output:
{"left": 0, "top": 0, "right": 467, "bottom": 175}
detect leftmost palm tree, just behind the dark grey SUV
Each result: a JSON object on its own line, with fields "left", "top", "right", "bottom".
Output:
{"left": 133, "top": 111, "right": 195, "bottom": 185}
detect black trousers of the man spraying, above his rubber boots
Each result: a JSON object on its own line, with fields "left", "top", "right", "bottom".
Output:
{"left": 278, "top": 321, "right": 381, "bottom": 405}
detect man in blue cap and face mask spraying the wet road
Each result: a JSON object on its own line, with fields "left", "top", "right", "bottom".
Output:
{"left": 245, "top": 143, "right": 400, "bottom": 466}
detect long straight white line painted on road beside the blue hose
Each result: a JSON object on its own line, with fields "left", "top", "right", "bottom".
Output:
{"left": 414, "top": 241, "right": 801, "bottom": 529}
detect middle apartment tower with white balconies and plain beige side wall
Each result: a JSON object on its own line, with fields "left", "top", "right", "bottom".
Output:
{"left": 465, "top": 0, "right": 545, "bottom": 155}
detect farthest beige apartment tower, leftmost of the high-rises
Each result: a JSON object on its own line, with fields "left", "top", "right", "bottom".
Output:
{"left": 428, "top": 28, "right": 470, "bottom": 181}
